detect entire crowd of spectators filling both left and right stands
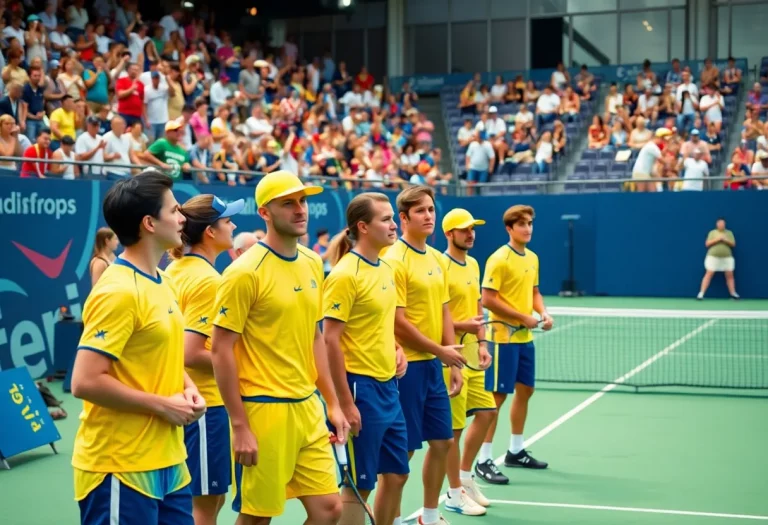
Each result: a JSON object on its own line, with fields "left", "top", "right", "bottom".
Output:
{"left": 0, "top": 0, "right": 768, "bottom": 193}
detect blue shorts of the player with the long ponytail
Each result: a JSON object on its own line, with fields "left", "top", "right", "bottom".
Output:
{"left": 347, "top": 373, "right": 410, "bottom": 490}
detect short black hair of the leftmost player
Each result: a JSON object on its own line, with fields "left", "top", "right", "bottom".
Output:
{"left": 102, "top": 169, "right": 173, "bottom": 247}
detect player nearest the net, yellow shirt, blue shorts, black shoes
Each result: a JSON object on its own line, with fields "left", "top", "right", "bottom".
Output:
{"left": 475, "top": 205, "right": 553, "bottom": 474}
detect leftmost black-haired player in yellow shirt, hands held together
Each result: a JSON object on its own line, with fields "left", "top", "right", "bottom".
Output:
{"left": 72, "top": 170, "right": 205, "bottom": 525}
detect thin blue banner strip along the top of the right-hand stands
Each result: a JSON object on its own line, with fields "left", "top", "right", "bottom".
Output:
{"left": 389, "top": 58, "right": 747, "bottom": 95}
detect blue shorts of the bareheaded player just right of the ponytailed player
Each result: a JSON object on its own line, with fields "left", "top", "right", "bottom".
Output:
{"left": 398, "top": 359, "right": 453, "bottom": 451}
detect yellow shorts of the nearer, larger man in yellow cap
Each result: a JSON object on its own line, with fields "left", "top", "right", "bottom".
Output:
{"left": 233, "top": 394, "right": 339, "bottom": 518}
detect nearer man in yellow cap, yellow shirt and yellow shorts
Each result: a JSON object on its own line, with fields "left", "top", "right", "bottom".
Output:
{"left": 212, "top": 171, "right": 349, "bottom": 525}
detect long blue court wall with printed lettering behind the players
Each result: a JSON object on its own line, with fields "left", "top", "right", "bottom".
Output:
{"left": 0, "top": 179, "right": 768, "bottom": 377}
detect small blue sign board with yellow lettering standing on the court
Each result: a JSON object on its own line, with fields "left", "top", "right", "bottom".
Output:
{"left": 0, "top": 367, "right": 61, "bottom": 468}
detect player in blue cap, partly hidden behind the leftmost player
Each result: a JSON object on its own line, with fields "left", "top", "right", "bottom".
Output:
{"left": 166, "top": 195, "right": 245, "bottom": 525}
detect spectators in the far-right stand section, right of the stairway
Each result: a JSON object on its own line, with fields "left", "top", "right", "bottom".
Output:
{"left": 588, "top": 58, "right": 768, "bottom": 190}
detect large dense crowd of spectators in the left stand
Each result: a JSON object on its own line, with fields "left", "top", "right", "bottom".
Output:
{"left": 0, "top": 0, "right": 451, "bottom": 188}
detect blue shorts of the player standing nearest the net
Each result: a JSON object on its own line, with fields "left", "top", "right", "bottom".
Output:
{"left": 485, "top": 341, "right": 536, "bottom": 394}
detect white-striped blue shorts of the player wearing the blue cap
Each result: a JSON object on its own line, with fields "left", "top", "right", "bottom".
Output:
{"left": 184, "top": 406, "right": 232, "bottom": 496}
